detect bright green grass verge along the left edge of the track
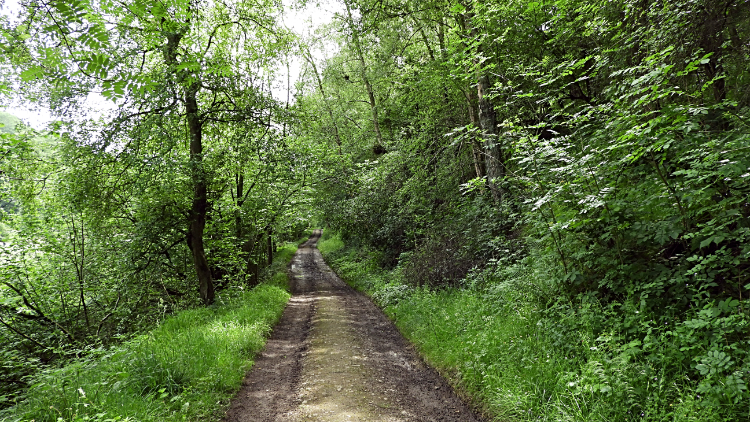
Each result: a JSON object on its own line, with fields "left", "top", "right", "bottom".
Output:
{"left": 0, "top": 245, "right": 296, "bottom": 422}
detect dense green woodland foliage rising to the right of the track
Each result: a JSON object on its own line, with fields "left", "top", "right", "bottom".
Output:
{"left": 301, "top": 0, "right": 750, "bottom": 420}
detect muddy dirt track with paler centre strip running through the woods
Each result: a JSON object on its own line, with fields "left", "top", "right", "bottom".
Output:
{"left": 224, "top": 230, "right": 480, "bottom": 422}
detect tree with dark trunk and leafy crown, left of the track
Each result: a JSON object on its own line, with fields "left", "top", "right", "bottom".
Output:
{"left": 13, "top": 1, "right": 286, "bottom": 304}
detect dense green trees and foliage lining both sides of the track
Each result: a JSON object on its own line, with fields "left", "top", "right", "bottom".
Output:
{"left": 0, "top": 0, "right": 750, "bottom": 420}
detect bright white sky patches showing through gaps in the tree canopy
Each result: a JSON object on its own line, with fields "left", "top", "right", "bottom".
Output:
{"left": 0, "top": 0, "right": 342, "bottom": 129}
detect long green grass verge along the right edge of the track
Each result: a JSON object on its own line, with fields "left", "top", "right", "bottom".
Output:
{"left": 321, "top": 234, "right": 742, "bottom": 422}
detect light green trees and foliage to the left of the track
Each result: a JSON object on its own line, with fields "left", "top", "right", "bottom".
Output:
{"left": 0, "top": 1, "right": 317, "bottom": 408}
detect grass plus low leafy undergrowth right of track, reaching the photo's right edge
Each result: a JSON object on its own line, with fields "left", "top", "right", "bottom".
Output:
{"left": 319, "top": 233, "right": 750, "bottom": 422}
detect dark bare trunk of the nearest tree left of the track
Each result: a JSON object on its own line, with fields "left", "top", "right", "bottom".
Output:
{"left": 185, "top": 86, "right": 214, "bottom": 305}
